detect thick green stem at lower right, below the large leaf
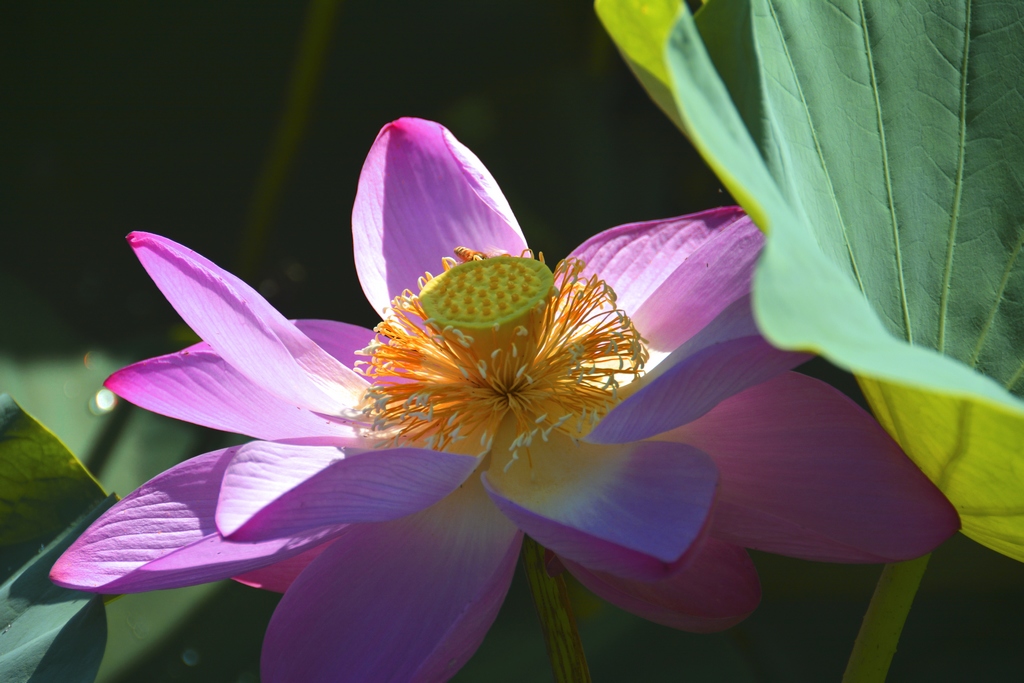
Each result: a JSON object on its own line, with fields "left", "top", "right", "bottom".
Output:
{"left": 843, "top": 554, "right": 931, "bottom": 683}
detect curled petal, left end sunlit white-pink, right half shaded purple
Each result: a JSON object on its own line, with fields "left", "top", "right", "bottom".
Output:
{"left": 217, "top": 441, "right": 479, "bottom": 542}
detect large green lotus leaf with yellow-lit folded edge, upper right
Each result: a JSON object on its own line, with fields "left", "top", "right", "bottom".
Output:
{"left": 598, "top": 0, "right": 1024, "bottom": 560}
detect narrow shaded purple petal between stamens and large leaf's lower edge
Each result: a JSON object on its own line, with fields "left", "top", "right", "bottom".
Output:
{"left": 586, "top": 296, "right": 810, "bottom": 443}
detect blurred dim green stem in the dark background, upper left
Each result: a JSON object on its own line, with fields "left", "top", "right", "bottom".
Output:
{"left": 236, "top": 0, "right": 341, "bottom": 279}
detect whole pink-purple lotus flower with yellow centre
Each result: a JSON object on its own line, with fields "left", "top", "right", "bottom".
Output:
{"left": 51, "top": 119, "right": 958, "bottom": 681}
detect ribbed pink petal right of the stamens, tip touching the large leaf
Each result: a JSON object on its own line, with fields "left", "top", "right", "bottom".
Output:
{"left": 572, "top": 207, "right": 764, "bottom": 356}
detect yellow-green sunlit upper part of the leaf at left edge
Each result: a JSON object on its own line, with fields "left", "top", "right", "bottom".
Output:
{"left": 0, "top": 394, "right": 106, "bottom": 547}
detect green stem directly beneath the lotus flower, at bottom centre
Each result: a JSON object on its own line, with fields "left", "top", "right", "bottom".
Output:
{"left": 522, "top": 536, "right": 590, "bottom": 683}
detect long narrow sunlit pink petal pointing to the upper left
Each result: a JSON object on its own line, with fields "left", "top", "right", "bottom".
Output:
{"left": 128, "top": 232, "right": 367, "bottom": 416}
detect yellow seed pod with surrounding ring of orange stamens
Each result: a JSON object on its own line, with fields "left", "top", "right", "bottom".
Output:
{"left": 359, "top": 250, "right": 647, "bottom": 468}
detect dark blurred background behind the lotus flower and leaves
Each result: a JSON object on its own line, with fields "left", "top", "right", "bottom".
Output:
{"left": 0, "top": 0, "right": 1024, "bottom": 683}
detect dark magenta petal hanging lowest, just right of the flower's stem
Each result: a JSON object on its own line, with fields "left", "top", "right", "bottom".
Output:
{"left": 565, "top": 539, "right": 761, "bottom": 633}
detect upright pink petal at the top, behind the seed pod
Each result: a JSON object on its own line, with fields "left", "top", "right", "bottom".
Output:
{"left": 352, "top": 119, "right": 526, "bottom": 313}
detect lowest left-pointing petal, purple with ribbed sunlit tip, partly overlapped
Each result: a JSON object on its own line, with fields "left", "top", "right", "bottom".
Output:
{"left": 50, "top": 447, "right": 344, "bottom": 593}
